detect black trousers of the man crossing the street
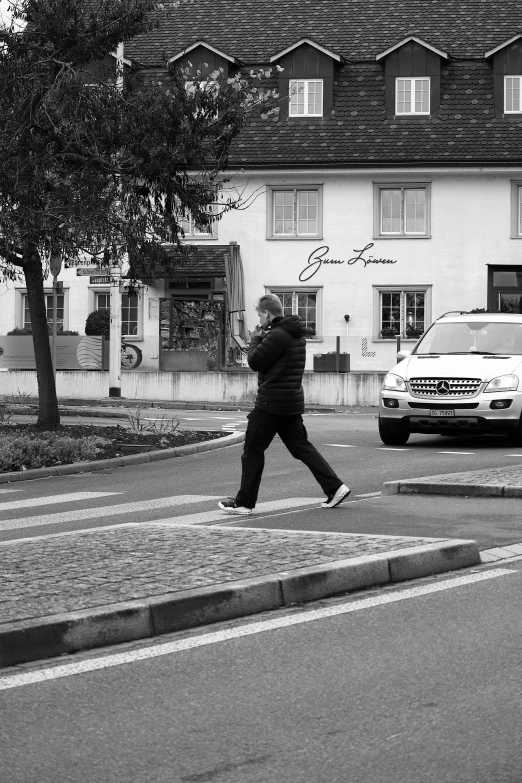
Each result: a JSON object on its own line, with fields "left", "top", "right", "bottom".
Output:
{"left": 235, "top": 408, "right": 343, "bottom": 508}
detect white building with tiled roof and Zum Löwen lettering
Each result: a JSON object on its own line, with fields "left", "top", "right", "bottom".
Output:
{"left": 0, "top": 0, "right": 522, "bottom": 371}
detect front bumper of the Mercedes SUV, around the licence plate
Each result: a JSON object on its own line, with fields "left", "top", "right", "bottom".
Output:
{"left": 379, "top": 390, "right": 522, "bottom": 435}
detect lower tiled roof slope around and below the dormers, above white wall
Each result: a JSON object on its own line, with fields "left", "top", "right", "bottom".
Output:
{"left": 230, "top": 62, "right": 522, "bottom": 168}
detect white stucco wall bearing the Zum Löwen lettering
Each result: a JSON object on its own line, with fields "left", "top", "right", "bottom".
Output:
{"left": 0, "top": 167, "right": 522, "bottom": 372}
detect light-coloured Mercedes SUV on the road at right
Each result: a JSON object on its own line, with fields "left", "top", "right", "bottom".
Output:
{"left": 379, "top": 312, "right": 522, "bottom": 445}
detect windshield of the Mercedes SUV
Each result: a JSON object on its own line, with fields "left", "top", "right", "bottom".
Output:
{"left": 413, "top": 320, "right": 522, "bottom": 356}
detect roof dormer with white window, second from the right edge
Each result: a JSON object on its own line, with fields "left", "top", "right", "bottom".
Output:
{"left": 376, "top": 35, "right": 449, "bottom": 120}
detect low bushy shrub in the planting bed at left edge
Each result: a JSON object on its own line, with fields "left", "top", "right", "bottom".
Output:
{"left": 0, "top": 431, "right": 107, "bottom": 472}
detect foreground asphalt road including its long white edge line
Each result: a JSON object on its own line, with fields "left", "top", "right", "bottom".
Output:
{"left": 0, "top": 562, "right": 522, "bottom": 783}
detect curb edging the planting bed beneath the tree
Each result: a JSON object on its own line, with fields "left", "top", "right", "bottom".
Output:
{"left": 0, "top": 432, "right": 245, "bottom": 484}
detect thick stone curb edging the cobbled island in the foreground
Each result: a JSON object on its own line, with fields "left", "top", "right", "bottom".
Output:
{"left": 0, "top": 539, "right": 480, "bottom": 668}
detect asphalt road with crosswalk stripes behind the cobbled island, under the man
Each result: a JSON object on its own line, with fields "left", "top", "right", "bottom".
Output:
{"left": 0, "top": 409, "right": 522, "bottom": 548}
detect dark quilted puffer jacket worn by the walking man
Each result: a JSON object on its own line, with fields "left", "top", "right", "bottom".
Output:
{"left": 248, "top": 315, "right": 306, "bottom": 416}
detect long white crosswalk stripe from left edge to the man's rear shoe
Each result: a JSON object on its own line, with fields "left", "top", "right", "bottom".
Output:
{"left": 0, "top": 493, "right": 222, "bottom": 530}
